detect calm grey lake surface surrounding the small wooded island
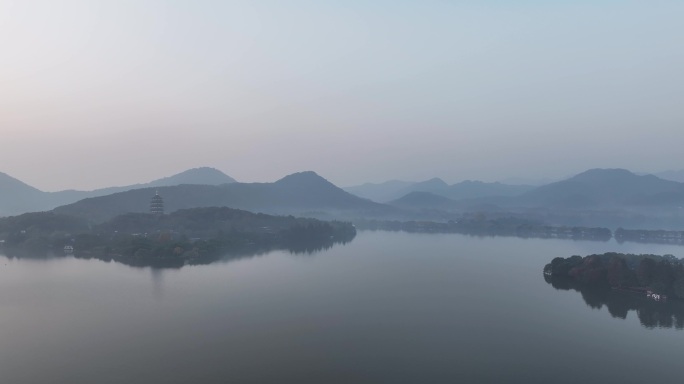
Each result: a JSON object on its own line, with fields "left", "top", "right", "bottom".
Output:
{"left": 0, "top": 232, "right": 684, "bottom": 384}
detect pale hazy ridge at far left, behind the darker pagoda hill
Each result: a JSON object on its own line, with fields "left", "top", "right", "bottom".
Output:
{"left": 0, "top": 167, "right": 235, "bottom": 216}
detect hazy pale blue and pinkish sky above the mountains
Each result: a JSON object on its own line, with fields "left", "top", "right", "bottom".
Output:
{"left": 0, "top": 0, "right": 684, "bottom": 190}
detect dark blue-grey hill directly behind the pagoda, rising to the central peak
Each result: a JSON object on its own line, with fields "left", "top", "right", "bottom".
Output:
{"left": 55, "top": 172, "right": 394, "bottom": 222}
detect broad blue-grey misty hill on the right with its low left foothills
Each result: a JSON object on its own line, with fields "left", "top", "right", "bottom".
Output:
{"left": 390, "top": 169, "right": 684, "bottom": 228}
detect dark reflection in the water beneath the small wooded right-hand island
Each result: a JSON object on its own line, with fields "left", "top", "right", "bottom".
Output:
{"left": 544, "top": 275, "right": 684, "bottom": 330}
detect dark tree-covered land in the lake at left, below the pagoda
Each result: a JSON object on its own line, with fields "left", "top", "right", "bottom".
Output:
{"left": 0, "top": 207, "right": 356, "bottom": 267}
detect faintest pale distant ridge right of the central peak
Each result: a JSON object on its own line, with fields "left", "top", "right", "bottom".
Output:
{"left": 345, "top": 178, "right": 534, "bottom": 202}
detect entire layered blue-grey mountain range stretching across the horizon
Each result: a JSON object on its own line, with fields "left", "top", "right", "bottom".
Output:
{"left": 0, "top": 168, "right": 684, "bottom": 227}
